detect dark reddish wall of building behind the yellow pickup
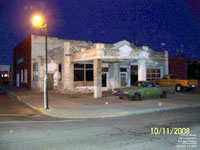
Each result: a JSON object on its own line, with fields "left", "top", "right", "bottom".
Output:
{"left": 169, "top": 56, "right": 187, "bottom": 79}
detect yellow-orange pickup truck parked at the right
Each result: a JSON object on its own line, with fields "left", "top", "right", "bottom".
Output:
{"left": 155, "top": 74, "right": 198, "bottom": 92}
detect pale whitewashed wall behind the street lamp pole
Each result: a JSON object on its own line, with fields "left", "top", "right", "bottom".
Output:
{"left": 31, "top": 35, "right": 91, "bottom": 89}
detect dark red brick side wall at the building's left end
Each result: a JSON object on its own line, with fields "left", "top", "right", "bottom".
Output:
{"left": 13, "top": 35, "right": 31, "bottom": 88}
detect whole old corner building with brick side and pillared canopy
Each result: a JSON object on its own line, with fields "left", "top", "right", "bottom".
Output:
{"left": 13, "top": 35, "right": 169, "bottom": 98}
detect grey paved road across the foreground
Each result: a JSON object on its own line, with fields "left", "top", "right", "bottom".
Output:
{"left": 0, "top": 103, "right": 200, "bottom": 150}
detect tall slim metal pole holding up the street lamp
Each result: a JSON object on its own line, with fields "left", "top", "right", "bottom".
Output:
{"left": 44, "top": 24, "right": 49, "bottom": 109}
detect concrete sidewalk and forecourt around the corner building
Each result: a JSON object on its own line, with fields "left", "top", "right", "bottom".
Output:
{"left": 5, "top": 90, "right": 200, "bottom": 118}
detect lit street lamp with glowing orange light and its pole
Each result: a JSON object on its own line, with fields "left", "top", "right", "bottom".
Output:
{"left": 33, "top": 15, "right": 49, "bottom": 109}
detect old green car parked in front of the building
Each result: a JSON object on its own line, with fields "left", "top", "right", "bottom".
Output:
{"left": 114, "top": 81, "right": 174, "bottom": 100}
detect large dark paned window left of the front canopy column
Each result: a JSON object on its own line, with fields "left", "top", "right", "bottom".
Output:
{"left": 74, "top": 64, "right": 93, "bottom": 81}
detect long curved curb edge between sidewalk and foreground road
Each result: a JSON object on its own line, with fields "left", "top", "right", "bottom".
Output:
{"left": 5, "top": 91, "right": 200, "bottom": 119}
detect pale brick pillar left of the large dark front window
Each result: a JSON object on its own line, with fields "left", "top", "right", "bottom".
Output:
{"left": 62, "top": 42, "right": 74, "bottom": 93}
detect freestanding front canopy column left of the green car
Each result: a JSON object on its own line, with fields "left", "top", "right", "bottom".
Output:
{"left": 93, "top": 59, "right": 102, "bottom": 98}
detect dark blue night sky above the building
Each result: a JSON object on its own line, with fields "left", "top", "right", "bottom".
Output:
{"left": 0, "top": 0, "right": 200, "bottom": 64}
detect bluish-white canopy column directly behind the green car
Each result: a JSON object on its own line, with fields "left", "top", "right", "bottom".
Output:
{"left": 138, "top": 59, "right": 147, "bottom": 81}
